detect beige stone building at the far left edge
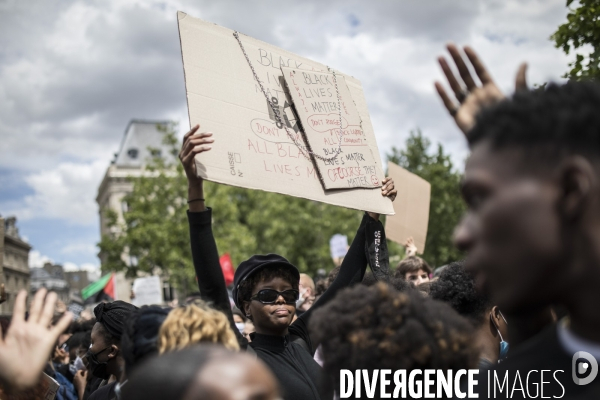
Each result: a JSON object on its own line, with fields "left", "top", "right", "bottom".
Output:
{"left": 0, "top": 217, "right": 31, "bottom": 315}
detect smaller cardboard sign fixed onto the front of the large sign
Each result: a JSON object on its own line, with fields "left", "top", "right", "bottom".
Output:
{"left": 281, "top": 67, "right": 382, "bottom": 189}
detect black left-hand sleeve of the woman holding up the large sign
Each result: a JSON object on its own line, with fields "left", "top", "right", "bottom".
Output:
{"left": 187, "top": 208, "right": 248, "bottom": 348}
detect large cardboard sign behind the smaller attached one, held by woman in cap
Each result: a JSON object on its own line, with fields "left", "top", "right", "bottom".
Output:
{"left": 178, "top": 12, "right": 394, "bottom": 214}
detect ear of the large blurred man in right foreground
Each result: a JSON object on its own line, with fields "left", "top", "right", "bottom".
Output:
{"left": 558, "top": 156, "right": 596, "bottom": 221}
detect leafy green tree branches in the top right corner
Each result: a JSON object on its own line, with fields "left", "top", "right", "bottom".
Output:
{"left": 550, "top": 0, "right": 600, "bottom": 80}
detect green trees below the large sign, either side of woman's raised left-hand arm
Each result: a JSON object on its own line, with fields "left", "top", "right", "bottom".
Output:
{"left": 98, "top": 125, "right": 362, "bottom": 292}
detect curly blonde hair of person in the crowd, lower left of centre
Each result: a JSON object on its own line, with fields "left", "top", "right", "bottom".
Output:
{"left": 158, "top": 300, "right": 240, "bottom": 354}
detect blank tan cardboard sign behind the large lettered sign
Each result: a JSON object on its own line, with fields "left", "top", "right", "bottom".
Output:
{"left": 385, "top": 162, "right": 431, "bottom": 253}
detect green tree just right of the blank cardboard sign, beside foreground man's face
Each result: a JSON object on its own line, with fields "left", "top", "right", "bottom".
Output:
{"left": 387, "top": 129, "right": 465, "bottom": 267}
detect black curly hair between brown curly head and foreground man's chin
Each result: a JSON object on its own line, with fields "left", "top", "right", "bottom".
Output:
{"left": 429, "top": 262, "right": 492, "bottom": 326}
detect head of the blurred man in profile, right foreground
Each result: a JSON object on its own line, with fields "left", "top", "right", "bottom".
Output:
{"left": 455, "top": 83, "right": 600, "bottom": 317}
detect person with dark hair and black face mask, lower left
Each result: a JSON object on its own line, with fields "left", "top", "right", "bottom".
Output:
{"left": 85, "top": 300, "right": 138, "bottom": 400}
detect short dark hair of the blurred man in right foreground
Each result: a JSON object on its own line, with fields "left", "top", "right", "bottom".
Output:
{"left": 467, "top": 81, "right": 600, "bottom": 165}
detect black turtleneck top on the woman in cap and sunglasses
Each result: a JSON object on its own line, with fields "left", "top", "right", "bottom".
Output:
{"left": 188, "top": 208, "right": 376, "bottom": 400}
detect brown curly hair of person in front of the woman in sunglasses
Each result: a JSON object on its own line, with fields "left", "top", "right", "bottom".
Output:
{"left": 310, "top": 283, "right": 478, "bottom": 393}
